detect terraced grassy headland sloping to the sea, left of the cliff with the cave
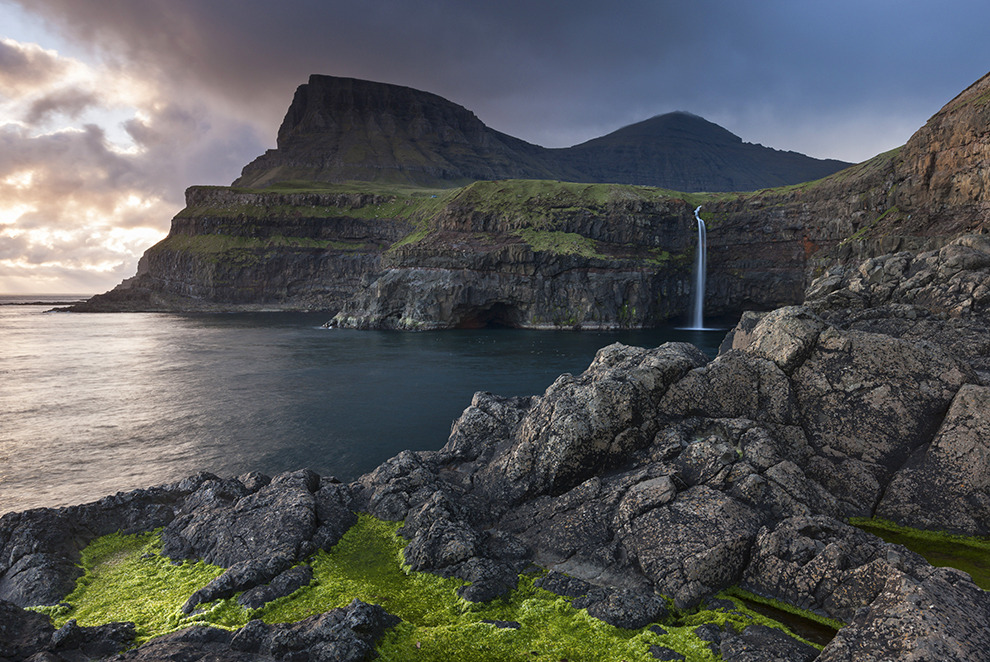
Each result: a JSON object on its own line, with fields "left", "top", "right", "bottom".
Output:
{"left": 78, "top": 187, "right": 412, "bottom": 311}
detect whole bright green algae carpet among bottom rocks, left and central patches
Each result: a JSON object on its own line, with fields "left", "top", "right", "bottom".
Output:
{"left": 38, "top": 515, "right": 828, "bottom": 662}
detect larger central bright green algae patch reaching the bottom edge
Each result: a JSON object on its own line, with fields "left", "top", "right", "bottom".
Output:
{"left": 255, "top": 515, "right": 684, "bottom": 662}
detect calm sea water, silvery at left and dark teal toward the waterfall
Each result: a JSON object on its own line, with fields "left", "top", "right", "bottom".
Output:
{"left": 0, "top": 297, "right": 723, "bottom": 513}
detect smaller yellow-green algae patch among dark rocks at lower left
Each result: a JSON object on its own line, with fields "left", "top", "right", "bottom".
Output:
{"left": 32, "top": 533, "right": 237, "bottom": 643}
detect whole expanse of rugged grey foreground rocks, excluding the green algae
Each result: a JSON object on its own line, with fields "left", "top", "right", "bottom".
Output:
{"left": 0, "top": 237, "right": 990, "bottom": 662}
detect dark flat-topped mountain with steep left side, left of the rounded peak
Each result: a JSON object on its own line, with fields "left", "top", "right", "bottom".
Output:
{"left": 234, "top": 76, "right": 572, "bottom": 187}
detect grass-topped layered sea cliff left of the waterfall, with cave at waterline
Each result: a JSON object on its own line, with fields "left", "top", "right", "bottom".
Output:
{"left": 76, "top": 180, "right": 712, "bottom": 329}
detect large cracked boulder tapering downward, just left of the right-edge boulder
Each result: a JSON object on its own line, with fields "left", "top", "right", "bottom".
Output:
{"left": 792, "top": 327, "right": 974, "bottom": 516}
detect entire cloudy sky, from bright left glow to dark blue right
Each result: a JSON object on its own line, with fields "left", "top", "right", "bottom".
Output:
{"left": 0, "top": 0, "right": 990, "bottom": 294}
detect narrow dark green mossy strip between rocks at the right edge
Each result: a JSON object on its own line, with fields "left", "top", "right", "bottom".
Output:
{"left": 849, "top": 517, "right": 990, "bottom": 591}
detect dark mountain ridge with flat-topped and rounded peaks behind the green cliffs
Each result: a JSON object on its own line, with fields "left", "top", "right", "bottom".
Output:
{"left": 234, "top": 75, "right": 849, "bottom": 191}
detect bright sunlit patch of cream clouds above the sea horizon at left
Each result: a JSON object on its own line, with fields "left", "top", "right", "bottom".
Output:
{"left": 0, "top": 32, "right": 259, "bottom": 293}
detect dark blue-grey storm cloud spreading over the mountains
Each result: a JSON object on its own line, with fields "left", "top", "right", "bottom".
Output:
{"left": 13, "top": 0, "right": 990, "bottom": 157}
